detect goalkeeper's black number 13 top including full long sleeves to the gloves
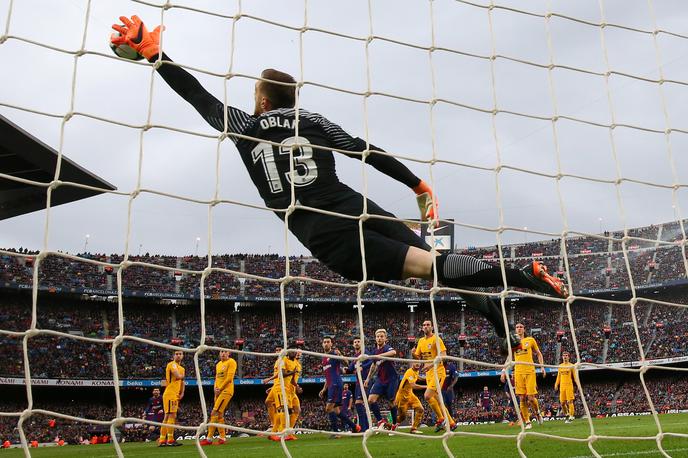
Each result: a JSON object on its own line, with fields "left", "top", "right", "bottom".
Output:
{"left": 153, "top": 54, "right": 420, "bottom": 209}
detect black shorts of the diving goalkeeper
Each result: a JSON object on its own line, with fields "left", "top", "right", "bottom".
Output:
{"left": 289, "top": 192, "right": 430, "bottom": 281}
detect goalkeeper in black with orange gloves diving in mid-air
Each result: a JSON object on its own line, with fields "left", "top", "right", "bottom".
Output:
{"left": 111, "top": 16, "right": 568, "bottom": 346}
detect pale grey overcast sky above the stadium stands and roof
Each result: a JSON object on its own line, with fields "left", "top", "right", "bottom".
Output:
{"left": 0, "top": 0, "right": 688, "bottom": 255}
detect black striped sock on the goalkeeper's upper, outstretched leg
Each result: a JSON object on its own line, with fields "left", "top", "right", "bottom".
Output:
{"left": 437, "top": 253, "right": 532, "bottom": 288}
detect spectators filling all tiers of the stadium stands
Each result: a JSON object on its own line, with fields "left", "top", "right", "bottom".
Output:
{"left": 0, "top": 223, "right": 688, "bottom": 443}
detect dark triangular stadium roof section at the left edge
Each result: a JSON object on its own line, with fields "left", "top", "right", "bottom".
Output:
{"left": 0, "top": 116, "right": 116, "bottom": 220}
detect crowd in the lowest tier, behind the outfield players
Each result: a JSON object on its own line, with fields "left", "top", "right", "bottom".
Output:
{"left": 0, "top": 374, "right": 688, "bottom": 444}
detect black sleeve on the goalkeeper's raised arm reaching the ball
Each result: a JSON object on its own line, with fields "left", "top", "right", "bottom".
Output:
{"left": 155, "top": 53, "right": 255, "bottom": 143}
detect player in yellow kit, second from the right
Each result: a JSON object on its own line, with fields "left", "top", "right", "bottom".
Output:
{"left": 501, "top": 323, "right": 547, "bottom": 429}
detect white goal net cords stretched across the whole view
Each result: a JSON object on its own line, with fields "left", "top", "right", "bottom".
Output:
{"left": 0, "top": 0, "right": 688, "bottom": 456}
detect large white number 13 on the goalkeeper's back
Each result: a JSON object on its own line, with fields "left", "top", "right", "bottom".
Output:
{"left": 251, "top": 137, "right": 318, "bottom": 194}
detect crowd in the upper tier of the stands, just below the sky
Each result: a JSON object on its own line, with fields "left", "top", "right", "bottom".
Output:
{"left": 0, "top": 222, "right": 686, "bottom": 301}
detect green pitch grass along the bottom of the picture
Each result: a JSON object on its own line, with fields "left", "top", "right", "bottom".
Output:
{"left": 8, "top": 414, "right": 688, "bottom": 458}
